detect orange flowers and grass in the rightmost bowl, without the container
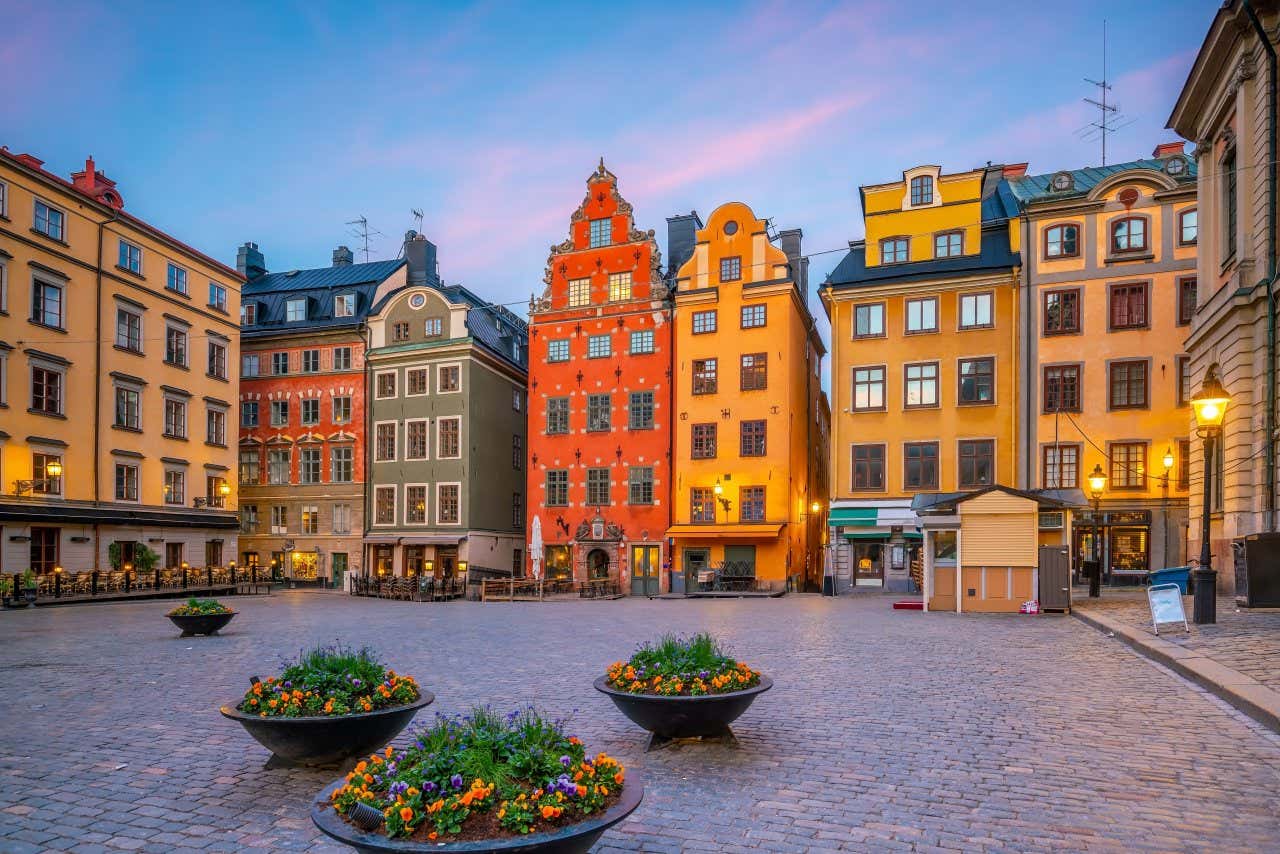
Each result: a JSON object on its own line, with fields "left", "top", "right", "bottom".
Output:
{"left": 605, "top": 632, "right": 760, "bottom": 697}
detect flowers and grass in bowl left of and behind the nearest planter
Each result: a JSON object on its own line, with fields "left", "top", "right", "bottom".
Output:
{"left": 236, "top": 647, "right": 421, "bottom": 717}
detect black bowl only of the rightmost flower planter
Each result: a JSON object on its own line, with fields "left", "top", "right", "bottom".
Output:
{"left": 595, "top": 676, "right": 773, "bottom": 749}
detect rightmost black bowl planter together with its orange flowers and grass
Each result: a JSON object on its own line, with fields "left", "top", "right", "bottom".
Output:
{"left": 595, "top": 632, "right": 773, "bottom": 750}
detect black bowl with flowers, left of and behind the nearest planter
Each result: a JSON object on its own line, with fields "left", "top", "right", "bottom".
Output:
{"left": 220, "top": 645, "right": 435, "bottom": 766}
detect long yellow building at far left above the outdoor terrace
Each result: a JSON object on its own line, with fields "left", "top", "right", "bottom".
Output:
{"left": 0, "top": 150, "right": 243, "bottom": 574}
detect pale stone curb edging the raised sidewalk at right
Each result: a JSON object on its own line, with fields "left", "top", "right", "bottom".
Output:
{"left": 1071, "top": 608, "right": 1280, "bottom": 732}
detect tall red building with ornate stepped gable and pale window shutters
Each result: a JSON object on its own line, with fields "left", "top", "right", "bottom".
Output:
{"left": 526, "top": 159, "right": 673, "bottom": 594}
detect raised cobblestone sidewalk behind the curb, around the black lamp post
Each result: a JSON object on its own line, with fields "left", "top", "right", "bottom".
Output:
{"left": 1073, "top": 590, "right": 1280, "bottom": 691}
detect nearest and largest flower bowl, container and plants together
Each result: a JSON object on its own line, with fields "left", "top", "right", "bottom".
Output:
{"left": 311, "top": 708, "right": 644, "bottom": 853}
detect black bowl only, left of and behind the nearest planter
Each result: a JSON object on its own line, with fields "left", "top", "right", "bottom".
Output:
{"left": 219, "top": 691, "right": 435, "bottom": 766}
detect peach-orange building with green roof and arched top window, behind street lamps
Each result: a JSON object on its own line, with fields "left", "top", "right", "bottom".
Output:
{"left": 1009, "top": 142, "right": 1198, "bottom": 581}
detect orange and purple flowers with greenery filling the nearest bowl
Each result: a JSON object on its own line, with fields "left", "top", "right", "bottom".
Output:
{"left": 330, "top": 708, "right": 624, "bottom": 842}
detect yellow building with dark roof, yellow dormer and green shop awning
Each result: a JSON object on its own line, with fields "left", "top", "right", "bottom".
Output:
{"left": 820, "top": 164, "right": 1025, "bottom": 590}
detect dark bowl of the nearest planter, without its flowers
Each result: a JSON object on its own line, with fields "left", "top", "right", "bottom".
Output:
{"left": 311, "top": 769, "right": 644, "bottom": 854}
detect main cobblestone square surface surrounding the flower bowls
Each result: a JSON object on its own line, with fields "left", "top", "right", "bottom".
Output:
{"left": 0, "top": 593, "right": 1280, "bottom": 851}
